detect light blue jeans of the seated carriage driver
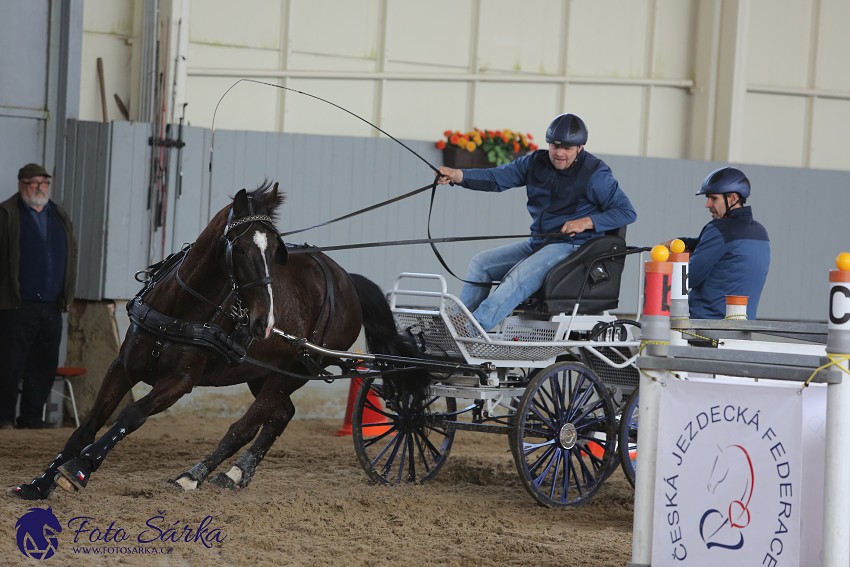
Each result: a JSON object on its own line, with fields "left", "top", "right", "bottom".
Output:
{"left": 460, "top": 240, "right": 578, "bottom": 331}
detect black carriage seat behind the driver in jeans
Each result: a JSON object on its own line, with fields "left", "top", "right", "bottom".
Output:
{"left": 520, "top": 227, "right": 626, "bottom": 315}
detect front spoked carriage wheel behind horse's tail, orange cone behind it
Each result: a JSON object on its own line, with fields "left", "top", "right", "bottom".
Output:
{"left": 351, "top": 378, "right": 457, "bottom": 485}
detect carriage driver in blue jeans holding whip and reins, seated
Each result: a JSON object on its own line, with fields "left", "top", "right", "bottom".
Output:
{"left": 438, "top": 114, "right": 637, "bottom": 331}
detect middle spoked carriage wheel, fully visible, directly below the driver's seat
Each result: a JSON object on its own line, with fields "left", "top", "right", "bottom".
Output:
{"left": 509, "top": 362, "right": 616, "bottom": 508}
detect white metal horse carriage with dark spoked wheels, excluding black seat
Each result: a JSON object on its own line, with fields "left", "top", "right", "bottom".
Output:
{"left": 344, "top": 270, "right": 640, "bottom": 508}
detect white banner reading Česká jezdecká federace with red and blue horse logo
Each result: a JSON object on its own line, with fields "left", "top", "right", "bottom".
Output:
{"left": 652, "top": 380, "right": 802, "bottom": 567}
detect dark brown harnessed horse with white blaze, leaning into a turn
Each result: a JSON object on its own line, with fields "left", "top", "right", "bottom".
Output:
{"left": 12, "top": 183, "right": 427, "bottom": 500}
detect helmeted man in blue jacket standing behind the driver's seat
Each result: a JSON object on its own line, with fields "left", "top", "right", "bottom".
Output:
{"left": 667, "top": 167, "right": 770, "bottom": 319}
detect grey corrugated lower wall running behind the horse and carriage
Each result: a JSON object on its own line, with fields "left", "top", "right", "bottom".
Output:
{"left": 59, "top": 122, "right": 850, "bottom": 320}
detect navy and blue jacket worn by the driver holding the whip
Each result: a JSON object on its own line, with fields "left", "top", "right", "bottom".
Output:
{"left": 460, "top": 150, "right": 637, "bottom": 246}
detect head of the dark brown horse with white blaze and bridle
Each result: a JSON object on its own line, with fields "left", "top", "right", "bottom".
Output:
{"left": 222, "top": 183, "right": 287, "bottom": 338}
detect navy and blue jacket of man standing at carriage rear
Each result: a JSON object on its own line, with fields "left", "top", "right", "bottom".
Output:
{"left": 682, "top": 207, "right": 770, "bottom": 319}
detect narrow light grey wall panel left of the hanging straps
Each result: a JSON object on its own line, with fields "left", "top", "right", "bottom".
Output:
{"left": 103, "top": 122, "right": 151, "bottom": 299}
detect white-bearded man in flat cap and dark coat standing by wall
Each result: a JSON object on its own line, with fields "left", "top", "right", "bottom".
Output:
{"left": 0, "top": 163, "right": 77, "bottom": 429}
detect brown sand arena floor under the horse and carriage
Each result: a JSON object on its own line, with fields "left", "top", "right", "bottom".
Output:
{"left": 0, "top": 414, "right": 634, "bottom": 567}
